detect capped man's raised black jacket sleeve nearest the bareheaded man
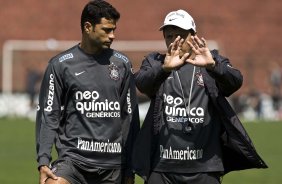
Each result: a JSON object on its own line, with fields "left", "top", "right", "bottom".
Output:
{"left": 135, "top": 53, "right": 170, "bottom": 98}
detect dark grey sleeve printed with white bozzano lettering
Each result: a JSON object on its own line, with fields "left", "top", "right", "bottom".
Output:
{"left": 35, "top": 62, "right": 62, "bottom": 167}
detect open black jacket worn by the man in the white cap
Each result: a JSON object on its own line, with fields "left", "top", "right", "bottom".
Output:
{"left": 133, "top": 50, "right": 267, "bottom": 180}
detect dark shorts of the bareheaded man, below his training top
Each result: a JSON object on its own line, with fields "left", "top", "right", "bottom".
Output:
{"left": 51, "top": 160, "right": 122, "bottom": 184}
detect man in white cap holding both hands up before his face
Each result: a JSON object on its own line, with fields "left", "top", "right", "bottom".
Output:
{"left": 133, "top": 10, "right": 267, "bottom": 184}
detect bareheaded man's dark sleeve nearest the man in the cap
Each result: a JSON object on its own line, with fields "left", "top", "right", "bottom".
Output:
{"left": 121, "top": 60, "right": 140, "bottom": 177}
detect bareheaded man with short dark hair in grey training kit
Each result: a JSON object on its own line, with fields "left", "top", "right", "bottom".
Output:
{"left": 36, "top": 0, "right": 139, "bottom": 184}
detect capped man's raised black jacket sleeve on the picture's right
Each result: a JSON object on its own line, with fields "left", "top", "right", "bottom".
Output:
{"left": 207, "top": 50, "right": 243, "bottom": 97}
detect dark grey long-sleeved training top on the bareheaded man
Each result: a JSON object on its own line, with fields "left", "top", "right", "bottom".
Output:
{"left": 36, "top": 45, "right": 139, "bottom": 175}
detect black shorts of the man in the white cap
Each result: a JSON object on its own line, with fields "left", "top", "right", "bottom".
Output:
{"left": 145, "top": 172, "right": 221, "bottom": 184}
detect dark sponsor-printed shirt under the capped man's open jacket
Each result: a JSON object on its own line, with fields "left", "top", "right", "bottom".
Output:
{"left": 153, "top": 64, "right": 223, "bottom": 173}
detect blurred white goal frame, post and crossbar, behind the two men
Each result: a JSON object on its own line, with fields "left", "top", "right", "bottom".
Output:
{"left": 2, "top": 39, "right": 218, "bottom": 94}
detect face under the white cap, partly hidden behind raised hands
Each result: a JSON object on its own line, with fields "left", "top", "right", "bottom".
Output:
{"left": 163, "top": 26, "right": 192, "bottom": 57}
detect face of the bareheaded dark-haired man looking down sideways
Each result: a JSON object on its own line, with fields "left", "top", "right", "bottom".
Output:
{"left": 86, "top": 18, "right": 116, "bottom": 50}
